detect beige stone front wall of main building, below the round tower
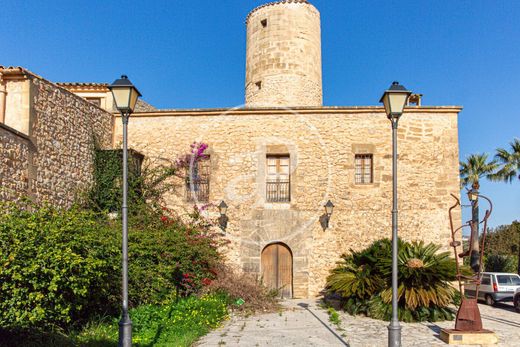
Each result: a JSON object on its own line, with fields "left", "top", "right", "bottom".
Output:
{"left": 115, "top": 107, "right": 460, "bottom": 297}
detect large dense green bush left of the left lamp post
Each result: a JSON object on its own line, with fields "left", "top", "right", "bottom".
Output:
{"left": 0, "top": 203, "right": 119, "bottom": 327}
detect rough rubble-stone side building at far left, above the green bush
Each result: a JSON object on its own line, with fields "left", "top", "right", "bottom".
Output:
{"left": 0, "top": 67, "right": 113, "bottom": 207}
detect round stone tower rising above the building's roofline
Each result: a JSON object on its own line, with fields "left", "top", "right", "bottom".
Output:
{"left": 246, "top": 0, "right": 323, "bottom": 107}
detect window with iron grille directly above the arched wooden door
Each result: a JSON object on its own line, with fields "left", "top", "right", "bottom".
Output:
{"left": 266, "top": 155, "right": 291, "bottom": 202}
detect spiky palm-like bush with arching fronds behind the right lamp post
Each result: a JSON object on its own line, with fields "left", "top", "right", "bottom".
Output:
{"left": 327, "top": 239, "right": 457, "bottom": 322}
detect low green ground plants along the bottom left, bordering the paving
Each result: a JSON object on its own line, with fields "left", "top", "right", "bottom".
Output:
{"left": 0, "top": 295, "right": 228, "bottom": 347}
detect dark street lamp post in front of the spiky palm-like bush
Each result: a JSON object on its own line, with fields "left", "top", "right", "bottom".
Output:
{"left": 379, "top": 82, "right": 411, "bottom": 347}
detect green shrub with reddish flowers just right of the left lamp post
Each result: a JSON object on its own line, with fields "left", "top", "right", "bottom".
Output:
{"left": 129, "top": 210, "right": 222, "bottom": 306}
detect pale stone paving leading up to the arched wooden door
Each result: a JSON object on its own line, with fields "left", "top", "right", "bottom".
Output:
{"left": 197, "top": 300, "right": 520, "bottom": 347}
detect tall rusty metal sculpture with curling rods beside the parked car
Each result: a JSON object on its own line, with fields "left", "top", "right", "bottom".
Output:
{"left": 449, "top": 194, "right": 493, "bottom": 332}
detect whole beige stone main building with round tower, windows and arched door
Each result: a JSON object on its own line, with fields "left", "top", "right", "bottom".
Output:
{"left": 1, "top": 0, "right": 461, "bottom": 297}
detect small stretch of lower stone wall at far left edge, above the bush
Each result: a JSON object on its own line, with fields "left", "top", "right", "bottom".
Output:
{"left": 0, "top": 123, "right": 31, "bottom": 201}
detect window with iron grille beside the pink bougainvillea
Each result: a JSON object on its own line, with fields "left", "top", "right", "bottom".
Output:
{"left": 186, "top": 157, "right": 210, "bottom": 202}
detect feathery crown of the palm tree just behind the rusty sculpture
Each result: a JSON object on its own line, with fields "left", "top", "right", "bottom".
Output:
{"left": 460, "top": 153, "right": 498, "bottom": 189}
